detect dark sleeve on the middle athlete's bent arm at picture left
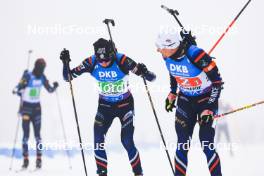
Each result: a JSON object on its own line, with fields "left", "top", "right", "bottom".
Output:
{"left": 63, "top": 57, "right": 93, "bottom": 81}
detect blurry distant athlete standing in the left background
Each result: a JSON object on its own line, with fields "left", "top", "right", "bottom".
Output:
{"left": 13, "top": 58, "right": 59, "bottom": 169}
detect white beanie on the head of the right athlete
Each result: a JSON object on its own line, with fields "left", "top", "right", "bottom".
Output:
{"left": 156, "top": 32, "right": 182, "bottom": 49}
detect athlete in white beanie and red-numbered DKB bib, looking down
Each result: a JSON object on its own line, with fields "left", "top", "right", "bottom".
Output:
{"left": 156, "top": 32, "right": 222, "bottom": 176}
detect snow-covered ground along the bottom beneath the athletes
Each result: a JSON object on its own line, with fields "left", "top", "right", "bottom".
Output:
{"left": 0, "top": 145, "right": 264, "bottom": 176}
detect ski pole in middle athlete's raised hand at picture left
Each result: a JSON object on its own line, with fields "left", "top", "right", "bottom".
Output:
{"left": 64, "top": 48, "right": 88, "bottom": 176}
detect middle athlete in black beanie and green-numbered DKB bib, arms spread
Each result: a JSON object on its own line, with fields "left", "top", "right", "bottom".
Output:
{"left": 61, "top": 38, "right": 156, "bottom": 176}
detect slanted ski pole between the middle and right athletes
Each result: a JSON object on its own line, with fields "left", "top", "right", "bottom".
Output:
{"left": 142, "top": 77, "right": 174, "bottom": 175}
